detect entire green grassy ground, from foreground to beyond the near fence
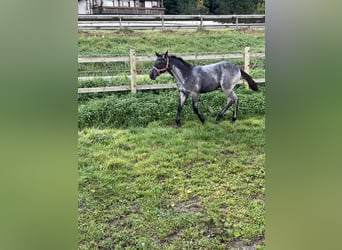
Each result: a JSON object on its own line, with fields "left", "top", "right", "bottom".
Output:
{"left": 78, "top": 27, "right": 265, "bottom": 249}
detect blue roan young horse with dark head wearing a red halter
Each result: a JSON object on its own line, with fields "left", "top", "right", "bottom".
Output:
{"left": 150, "top": 52, "right": 258, "bottom": 127}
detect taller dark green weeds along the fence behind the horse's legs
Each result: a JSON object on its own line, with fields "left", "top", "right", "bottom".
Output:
{"left": 78, "top": 84, "right": 265, "bottom": 128}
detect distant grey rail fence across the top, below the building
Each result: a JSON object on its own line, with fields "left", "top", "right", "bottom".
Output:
{"left": 78, "top": 14, "right": 265, "bottom": 30}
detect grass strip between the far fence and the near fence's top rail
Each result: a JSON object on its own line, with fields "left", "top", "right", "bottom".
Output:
{"left": 78, "top": 29, "right": 265, "bottom": 56}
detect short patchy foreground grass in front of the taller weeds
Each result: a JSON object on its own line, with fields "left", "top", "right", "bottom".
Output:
{"left": 78, "top": 115, "right": 265, "bottom": 249}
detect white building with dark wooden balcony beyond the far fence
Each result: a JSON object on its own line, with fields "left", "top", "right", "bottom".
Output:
{"left": 78, "top": 0, "right": 165, "bottom": 15}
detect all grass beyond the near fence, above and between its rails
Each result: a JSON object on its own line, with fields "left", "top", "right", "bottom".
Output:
{"left": 78, "top": 29, "right": 265, "bottom": 77}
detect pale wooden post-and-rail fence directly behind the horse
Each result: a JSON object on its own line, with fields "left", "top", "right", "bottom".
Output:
{"left": 78, "top": 47, "right": 265, "bottom": 94}
